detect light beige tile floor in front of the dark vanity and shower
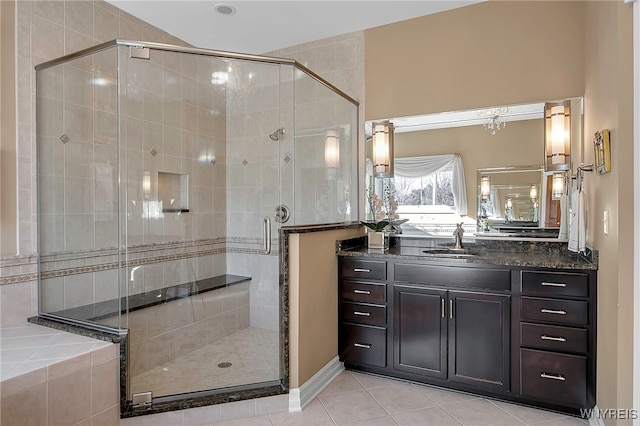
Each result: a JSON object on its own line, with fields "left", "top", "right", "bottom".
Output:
{"left": 121, "top": 371, "right": 588, "bottom": 426}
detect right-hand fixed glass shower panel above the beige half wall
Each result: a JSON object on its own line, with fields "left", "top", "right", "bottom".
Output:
{"left": 293, "top": 69, "right": 358, "bottom": 225}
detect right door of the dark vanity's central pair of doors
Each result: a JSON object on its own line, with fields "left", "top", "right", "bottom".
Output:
{"left": 449, "top": 290, "right": 511, "bottom": 390}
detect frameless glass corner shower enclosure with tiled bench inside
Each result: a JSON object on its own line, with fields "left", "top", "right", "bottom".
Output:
{"left": 36, "top": 40, "right": 358, "bottom": 410}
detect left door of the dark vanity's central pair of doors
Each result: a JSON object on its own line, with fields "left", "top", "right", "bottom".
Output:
{"left": 393, "top": 285, "right": 447, "bottom": 379}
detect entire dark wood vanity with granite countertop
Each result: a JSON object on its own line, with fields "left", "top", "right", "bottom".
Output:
{"left": 338, "top": 243, "right": 597, "bottom": 414}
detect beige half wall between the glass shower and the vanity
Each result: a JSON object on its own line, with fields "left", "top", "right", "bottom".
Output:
{"left": 289, "top": 228, "right": 364, "bottom": 389}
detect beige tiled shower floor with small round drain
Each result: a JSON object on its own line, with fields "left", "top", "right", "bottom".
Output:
{"left": 131, "top": 328, "right": 280, "bottom": 397}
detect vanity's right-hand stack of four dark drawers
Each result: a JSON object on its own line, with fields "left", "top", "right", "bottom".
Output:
{"left": 519, "top": 271, "right": 595, "bottom": 407}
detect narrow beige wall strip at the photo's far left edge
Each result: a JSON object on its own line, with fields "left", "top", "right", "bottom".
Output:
{"left": 0, "top": 1, "right": 17, "bottom": 256}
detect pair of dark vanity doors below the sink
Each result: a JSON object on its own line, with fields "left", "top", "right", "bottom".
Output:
{"left": 393, "top": 285, "right": 511, "bottom": 389}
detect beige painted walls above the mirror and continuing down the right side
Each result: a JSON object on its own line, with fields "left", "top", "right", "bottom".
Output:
{"left": 365, "top": 1, "right": 637, "bottom": 424}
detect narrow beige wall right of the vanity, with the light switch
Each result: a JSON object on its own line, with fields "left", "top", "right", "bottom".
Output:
{"left": 585, "top": 2, "right": 638, "bottom": 424}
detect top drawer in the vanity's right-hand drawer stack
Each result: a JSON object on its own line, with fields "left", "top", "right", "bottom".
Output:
{"left": 522, "top": 271, "right": 589, "bottom": 297}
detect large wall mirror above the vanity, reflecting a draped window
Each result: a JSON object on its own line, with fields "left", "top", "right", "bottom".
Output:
{"left": 365, "top": 97, "right": 583, "bottom": 240}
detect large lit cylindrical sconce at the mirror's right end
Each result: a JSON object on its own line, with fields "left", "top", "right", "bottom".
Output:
{"left": 544, "top": 101, "right": 571, "bottom": 171}
